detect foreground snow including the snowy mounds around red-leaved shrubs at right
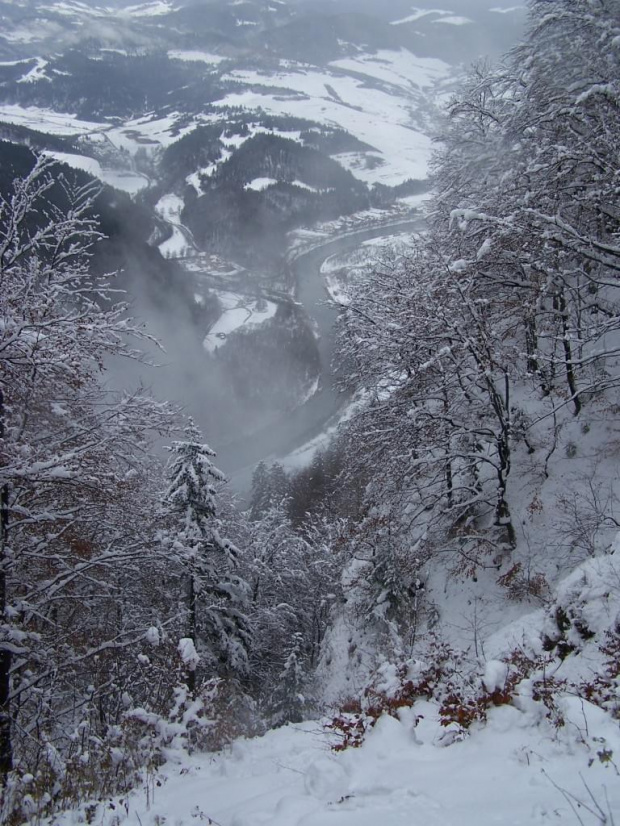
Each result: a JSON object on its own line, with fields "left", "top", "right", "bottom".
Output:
{"left": 44, "top": 535, "right": 620, "bottom": 826}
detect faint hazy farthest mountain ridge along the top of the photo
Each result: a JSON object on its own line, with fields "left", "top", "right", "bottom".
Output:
{"left": 0, "top": 0, "right": 524, "bottom": 61}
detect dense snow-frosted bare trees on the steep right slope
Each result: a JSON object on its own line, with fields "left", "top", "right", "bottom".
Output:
{"left": 341, "top": 0, "right": 620, "bottom": 596}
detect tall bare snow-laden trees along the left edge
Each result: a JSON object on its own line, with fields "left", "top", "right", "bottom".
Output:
{"left": 0, "top": 160, "right": 177, "bottom": 805}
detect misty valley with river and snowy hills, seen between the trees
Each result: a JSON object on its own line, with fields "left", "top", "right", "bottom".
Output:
{"left": 0, "top": 0, "right": 524, "bottom": 470}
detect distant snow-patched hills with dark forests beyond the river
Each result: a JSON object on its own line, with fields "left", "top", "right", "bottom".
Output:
{"left": 0, "top": 0, "right": 519, "bottom": 268}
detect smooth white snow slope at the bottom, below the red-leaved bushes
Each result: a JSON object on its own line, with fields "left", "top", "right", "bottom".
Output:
{"left": 55, "top": 698, "right": 620, "bottom": 826}
